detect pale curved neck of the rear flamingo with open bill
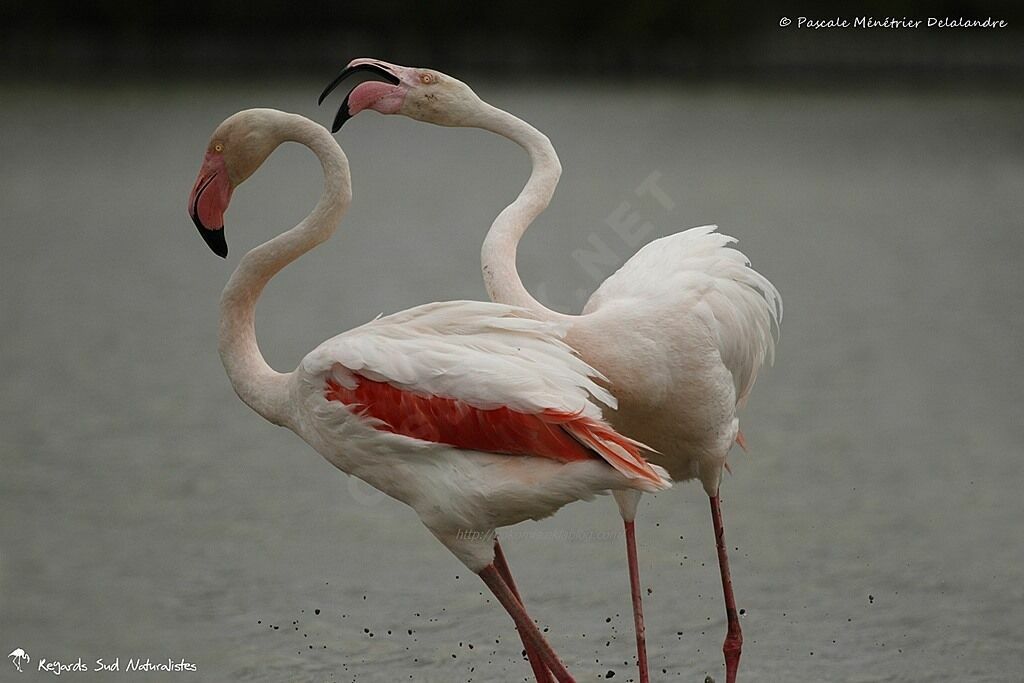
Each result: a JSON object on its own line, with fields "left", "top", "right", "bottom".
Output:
{"left": 473, "top": 102, "right": 565, "bottom": 319}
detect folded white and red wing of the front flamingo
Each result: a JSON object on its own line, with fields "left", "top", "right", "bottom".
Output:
{"left": 300, "top": 301, "right": 664, "bottom": 487}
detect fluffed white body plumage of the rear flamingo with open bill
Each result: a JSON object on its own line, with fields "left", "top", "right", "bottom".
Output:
{"left": 569, "top": 225, "right": 782, "bottom": 481}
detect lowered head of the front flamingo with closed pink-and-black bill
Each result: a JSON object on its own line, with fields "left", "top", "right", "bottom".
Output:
{"left": 188, "top": 110, "right": 283, "bottom": 258}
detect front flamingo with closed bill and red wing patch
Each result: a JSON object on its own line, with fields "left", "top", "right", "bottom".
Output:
{"left": 188, "top": 110, "right": 671, "bottom": 681}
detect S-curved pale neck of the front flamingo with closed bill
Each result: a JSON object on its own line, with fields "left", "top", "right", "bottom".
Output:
{"left": 218, "top": 115, "right": 352, "bottom": 424}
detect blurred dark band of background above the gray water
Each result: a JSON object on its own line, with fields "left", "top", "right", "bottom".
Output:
{"left": 6, "top": 0, "right": 1024, "bottom": 84}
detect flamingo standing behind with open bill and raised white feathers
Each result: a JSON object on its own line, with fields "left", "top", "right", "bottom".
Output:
{"left": 319, "top": 59, "right": 782, "bottom": 683}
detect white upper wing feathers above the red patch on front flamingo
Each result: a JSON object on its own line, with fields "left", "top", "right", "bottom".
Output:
{"left": 299, "top": 301, "right": 615, "bottom": 419}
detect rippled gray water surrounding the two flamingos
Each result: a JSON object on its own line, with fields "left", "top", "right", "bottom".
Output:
{"left": 0, "top": 83, "right": 1024, "bottom": 683}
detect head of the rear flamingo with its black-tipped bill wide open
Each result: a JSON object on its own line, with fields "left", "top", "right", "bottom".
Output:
{"left": 319, "top": 58, "right": 481, "bottom": 133}
